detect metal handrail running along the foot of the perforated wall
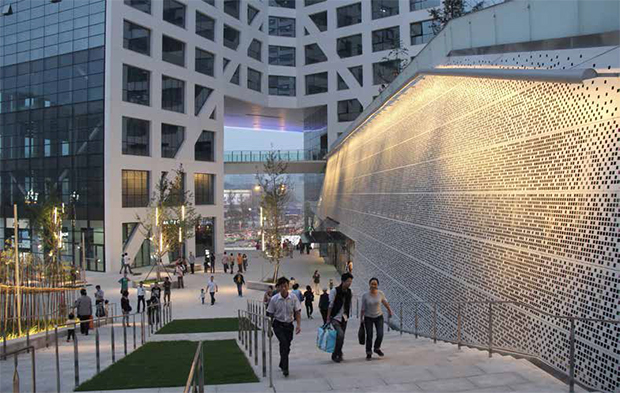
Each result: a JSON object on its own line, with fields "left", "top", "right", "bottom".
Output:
{"left": 356, "top": 297, "right": 620, "bottom": 393}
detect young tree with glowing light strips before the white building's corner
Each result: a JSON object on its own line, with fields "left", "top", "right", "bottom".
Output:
{"left": 136, "top": 166, "right": 200, "bottom": 280}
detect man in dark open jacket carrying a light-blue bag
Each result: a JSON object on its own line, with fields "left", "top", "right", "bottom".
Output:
{"left": 327, "top": 273, "right": 353, "bottom": 363}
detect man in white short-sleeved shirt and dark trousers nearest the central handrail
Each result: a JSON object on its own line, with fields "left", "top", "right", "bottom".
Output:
{"left": 267, "top": 277, "right": 301, "bottom": 377}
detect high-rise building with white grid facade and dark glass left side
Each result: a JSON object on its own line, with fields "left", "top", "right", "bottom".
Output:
{"left": 0, "top": 0, "right": 439, "bottom": 271}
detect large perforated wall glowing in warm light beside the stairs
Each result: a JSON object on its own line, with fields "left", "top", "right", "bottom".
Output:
{"left": 319, "top": 48, "right": 620, "bottom": 392}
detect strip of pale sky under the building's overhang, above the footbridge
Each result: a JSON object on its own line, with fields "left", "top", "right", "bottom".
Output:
{"left": 224, "top": 127, "right": 304, "bottom": 151}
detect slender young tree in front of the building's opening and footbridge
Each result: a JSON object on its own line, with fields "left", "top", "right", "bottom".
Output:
{"left": 256, "top": 150, "right": 291, "bottom": 282}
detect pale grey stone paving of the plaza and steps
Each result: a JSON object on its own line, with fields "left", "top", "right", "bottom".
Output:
{"left": 0, "top": 251, "right": 584, "bottom": 393}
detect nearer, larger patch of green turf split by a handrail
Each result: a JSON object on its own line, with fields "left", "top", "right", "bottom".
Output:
{"left": 75, "top": 340, "right": 258, "bottom": 391}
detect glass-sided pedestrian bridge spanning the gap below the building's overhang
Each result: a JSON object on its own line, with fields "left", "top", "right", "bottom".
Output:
{"left": 224, "top": 149, "right": 327, "bottom": 175}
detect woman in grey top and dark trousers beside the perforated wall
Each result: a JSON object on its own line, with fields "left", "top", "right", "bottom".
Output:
{"left": 361, "top": 277, "right": 392, "bottom": 360}
